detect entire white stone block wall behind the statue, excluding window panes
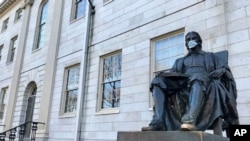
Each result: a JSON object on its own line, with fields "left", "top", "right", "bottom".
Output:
{"left": 0, "top": 0, "right": 250, "bottom": 141}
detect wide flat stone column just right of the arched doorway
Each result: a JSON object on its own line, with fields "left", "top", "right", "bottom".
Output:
{"left": 37, "top": 0, "right": 63, "bottom": 139}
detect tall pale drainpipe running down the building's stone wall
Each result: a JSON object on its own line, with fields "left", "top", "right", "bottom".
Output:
{"left": 74, "top": 0, "right": 95, "bottom": 141}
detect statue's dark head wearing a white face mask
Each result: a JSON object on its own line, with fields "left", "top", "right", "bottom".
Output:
{"left": 185, "top": 31, "right": 202, "bottom": 51}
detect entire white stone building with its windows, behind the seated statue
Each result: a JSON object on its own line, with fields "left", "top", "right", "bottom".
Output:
{"left": 0, "top": 0, "right": 250, "bottom": 141}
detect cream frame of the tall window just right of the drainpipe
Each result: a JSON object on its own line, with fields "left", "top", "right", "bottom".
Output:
{"left": 96, "top": 50, "right": 122, "bottom": 115}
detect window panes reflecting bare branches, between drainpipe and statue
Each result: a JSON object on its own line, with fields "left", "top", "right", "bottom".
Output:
{"left": 99, "top": 52, "right": 122, "bottom": 110}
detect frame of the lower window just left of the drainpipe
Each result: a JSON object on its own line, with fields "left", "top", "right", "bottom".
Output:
{"left": 60, "top": 63, "right": 80, "bottom": 117}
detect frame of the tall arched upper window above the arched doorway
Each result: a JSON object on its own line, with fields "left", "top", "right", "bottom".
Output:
{"left": 32, "top": 1, "right": 48, "bottom": 51}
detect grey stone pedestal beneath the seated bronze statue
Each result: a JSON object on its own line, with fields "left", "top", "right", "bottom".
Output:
{"left": 117, "top": 131, "right": 229, "bottom": 141}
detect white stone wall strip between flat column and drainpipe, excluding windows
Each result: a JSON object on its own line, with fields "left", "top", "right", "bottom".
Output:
{"left": 49, "top": 1, "right": 87, "bottom": 141}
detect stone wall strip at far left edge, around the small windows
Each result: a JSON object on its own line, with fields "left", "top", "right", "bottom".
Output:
{"left": 0, "top": 2, "right": 22, "bottom": 131}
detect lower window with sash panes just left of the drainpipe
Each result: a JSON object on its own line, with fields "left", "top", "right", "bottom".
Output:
{"left": 62, "top": 65, "right": 80, "bottom": 113}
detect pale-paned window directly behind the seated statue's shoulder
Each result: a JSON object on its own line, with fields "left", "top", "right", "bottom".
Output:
{"left": 152, "top": 30, "right": 185, "bottom": 74}
